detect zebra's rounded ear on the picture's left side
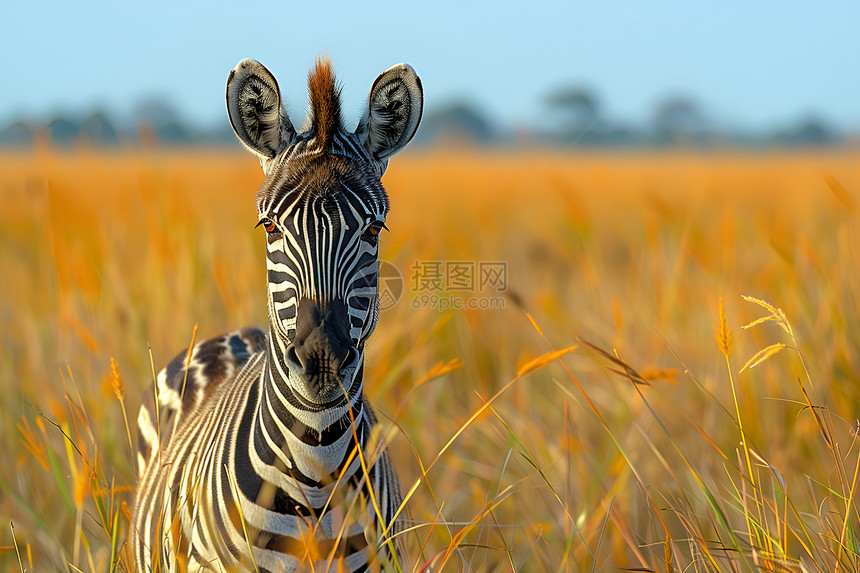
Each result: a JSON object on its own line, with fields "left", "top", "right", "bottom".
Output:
{"left": 227, "top": 59, "right": 296, "bottom": 170}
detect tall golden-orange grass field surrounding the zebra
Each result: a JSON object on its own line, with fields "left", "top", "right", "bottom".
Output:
{"left": 0, "top": 146, "right": 860, "bottom": 572}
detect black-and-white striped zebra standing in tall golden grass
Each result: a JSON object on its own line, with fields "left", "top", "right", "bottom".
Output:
{"left": 131, "top": 58, "right": 423, "bottom": 573}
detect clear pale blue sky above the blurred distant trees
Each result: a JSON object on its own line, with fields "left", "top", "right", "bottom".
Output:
{"left": 0, "top": 0, "right": 860, "bottom": 131}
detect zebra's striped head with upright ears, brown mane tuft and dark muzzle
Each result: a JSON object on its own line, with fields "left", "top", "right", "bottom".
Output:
{"left": 227, "top": 59, "right": 423, "bottom": 410}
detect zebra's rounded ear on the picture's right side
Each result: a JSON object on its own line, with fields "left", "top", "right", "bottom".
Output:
{"left": 355, "top": 64, "right": 424, "bottom": 163}
